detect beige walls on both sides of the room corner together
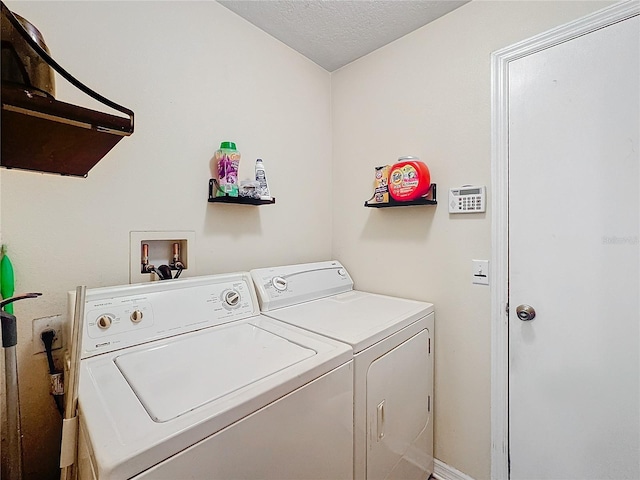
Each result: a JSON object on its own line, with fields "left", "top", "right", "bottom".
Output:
{"left": 0, "top": 0, "right": 608, "bottom": 479}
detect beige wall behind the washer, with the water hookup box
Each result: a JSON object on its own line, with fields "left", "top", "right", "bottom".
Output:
{"left": 0, "top": 0, "right": 331, "bottom": 479}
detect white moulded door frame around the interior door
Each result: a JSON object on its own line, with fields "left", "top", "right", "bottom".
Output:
{"left": 490, "top": 0, "right": 640, "bottom": 480}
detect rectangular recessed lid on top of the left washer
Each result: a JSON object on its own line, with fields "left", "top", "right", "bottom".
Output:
{"left": 115, "top": 323, "right": 316, "bottom": 422}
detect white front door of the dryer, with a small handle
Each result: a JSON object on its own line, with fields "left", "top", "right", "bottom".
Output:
{"left": 367, "top": 330, "right": 431, "bottom": 480}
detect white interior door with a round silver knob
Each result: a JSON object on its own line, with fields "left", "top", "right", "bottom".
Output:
{"left": 508, "top": 16, "right": 640, "bottom": 480}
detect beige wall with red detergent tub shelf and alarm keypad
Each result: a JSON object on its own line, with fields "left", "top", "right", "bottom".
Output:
{"left": 331, "top": 1, "right": 609, "bottom": 479}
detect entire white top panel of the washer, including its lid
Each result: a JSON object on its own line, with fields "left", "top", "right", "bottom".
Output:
{"left": 78, "top": 315, "right": 353, "bottom": 478}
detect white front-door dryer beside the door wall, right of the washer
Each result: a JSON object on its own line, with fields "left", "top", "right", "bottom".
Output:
{"left": 251, "top": 261, "right": 435, "bottom": 480}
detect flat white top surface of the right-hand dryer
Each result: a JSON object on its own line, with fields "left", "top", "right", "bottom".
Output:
{"left": 265, "top": 290, "right": 433, "bottom": 353}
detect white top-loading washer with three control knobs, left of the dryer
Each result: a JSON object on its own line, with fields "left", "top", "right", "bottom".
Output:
{"left": 75, "top": 272, "right": 353, "bottom": 480}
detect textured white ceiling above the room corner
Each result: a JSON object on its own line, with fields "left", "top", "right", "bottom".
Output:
{"left": 218, "top": 0, "right": 469, "bottom": 72}
